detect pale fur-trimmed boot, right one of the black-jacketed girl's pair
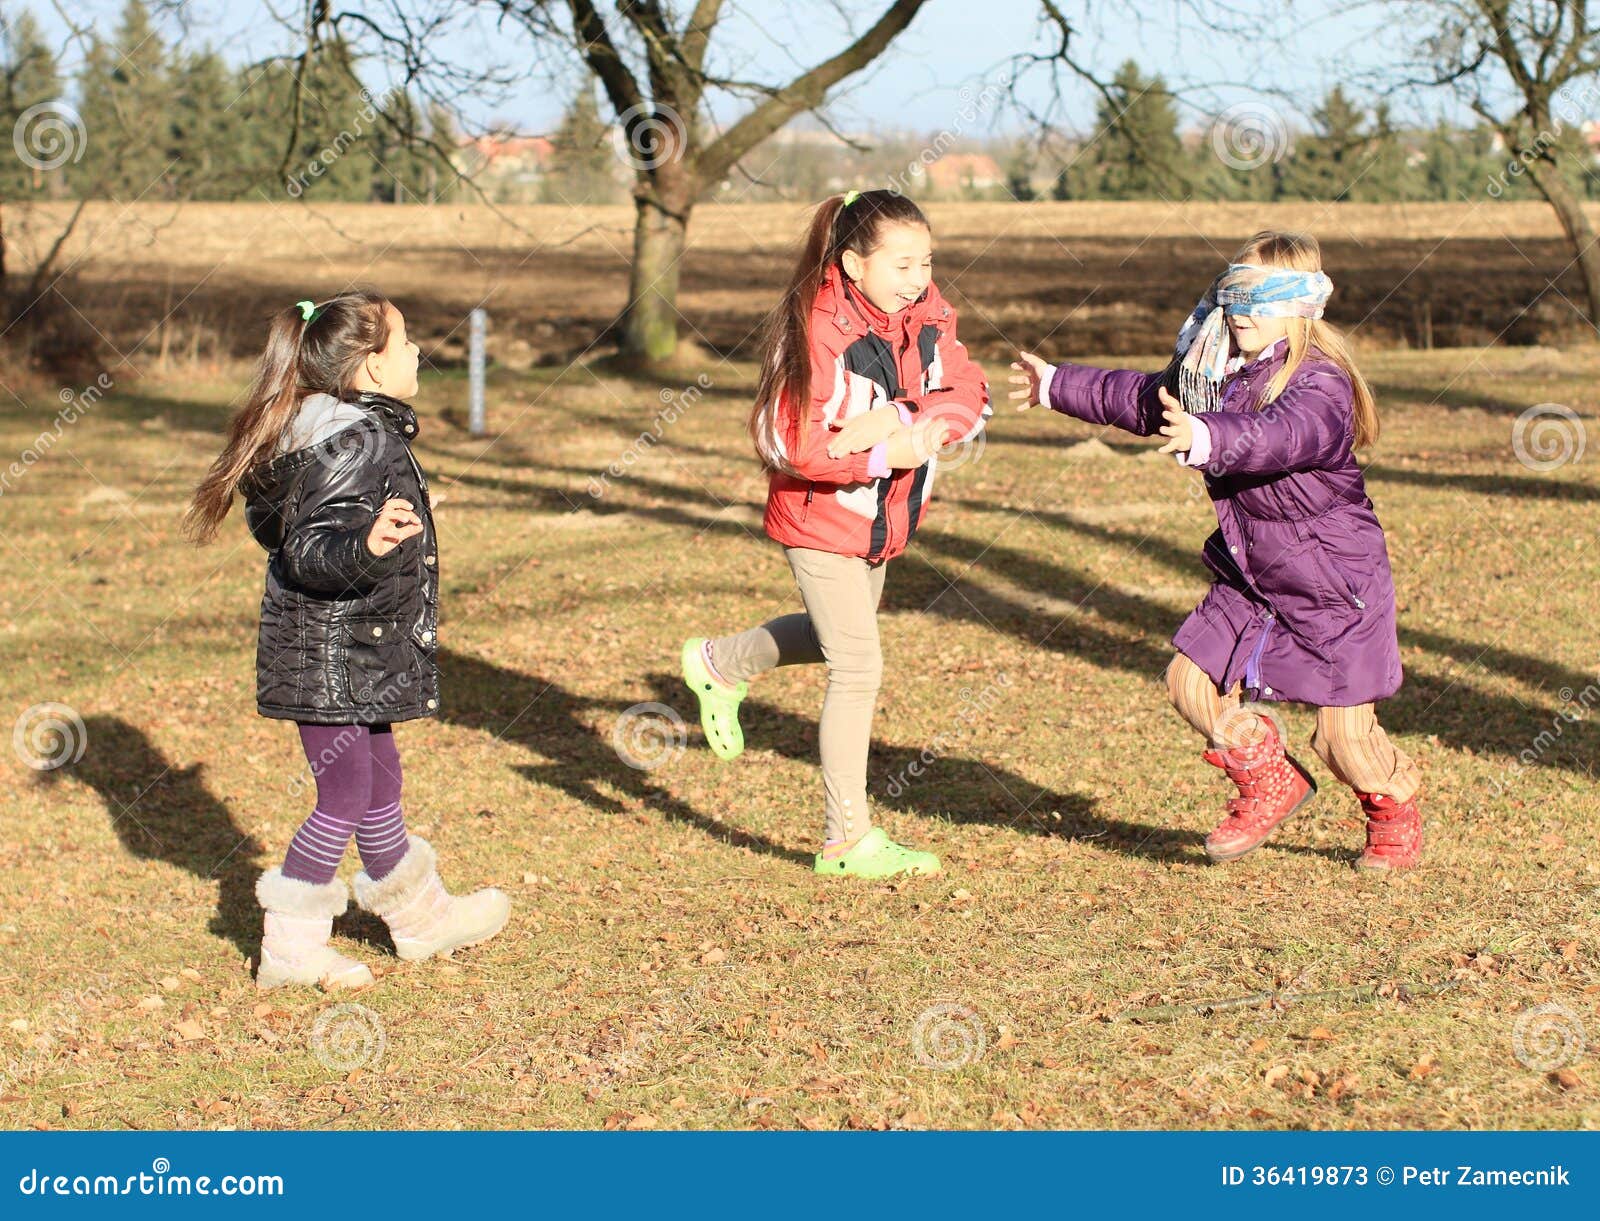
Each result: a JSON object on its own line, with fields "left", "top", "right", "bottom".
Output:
{"left": 355, "top": 835, "right": 510, "bottom": 959}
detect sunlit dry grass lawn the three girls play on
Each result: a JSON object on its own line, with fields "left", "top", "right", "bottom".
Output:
{"left": 0, "top": 347, "right": 1600, "bottom": 1128}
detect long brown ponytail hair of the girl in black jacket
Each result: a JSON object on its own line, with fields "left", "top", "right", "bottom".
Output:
{"left": 184, "top": 288, "right": 389, "bottom": 544}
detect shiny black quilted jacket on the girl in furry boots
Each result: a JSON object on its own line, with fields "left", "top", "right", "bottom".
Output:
{"left": 242, "top": 392, "right": 438, "bottom": 725}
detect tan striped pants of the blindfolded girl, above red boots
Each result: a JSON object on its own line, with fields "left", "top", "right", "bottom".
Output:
{"left": 1166, "top": 653, "right": 1422, "bottom": 802}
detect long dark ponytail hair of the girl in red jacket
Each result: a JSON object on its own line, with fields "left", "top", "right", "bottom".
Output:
{"left": 749, "top": 190, "right": 930, "bottom": 475}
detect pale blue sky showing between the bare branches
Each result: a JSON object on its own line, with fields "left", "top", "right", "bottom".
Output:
{"left": 18, "top": 0, "right": 1497, "bottom": 136}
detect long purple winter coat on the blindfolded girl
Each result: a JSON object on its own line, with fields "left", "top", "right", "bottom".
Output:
{"left": 1050, "top": 346, "right": 1400, "bottom": 707}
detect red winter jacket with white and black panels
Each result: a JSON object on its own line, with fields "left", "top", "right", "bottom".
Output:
{"left": 765, "top": 266, "right": 992, "bottom": 565}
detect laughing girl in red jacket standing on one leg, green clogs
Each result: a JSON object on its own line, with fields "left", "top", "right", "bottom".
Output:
{"left": 683, "top": 190, "right": 990, "bottom": 877}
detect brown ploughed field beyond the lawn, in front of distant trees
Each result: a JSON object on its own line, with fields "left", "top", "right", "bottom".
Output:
{"left": 6, "top": 198, "right": 1600, "bottom": 366}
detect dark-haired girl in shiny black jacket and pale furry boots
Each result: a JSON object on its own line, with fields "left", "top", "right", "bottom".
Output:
{"left": 184, "top": 290, "right": 510, "bottom": 987}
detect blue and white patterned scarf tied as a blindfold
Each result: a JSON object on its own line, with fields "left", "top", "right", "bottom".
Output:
{"left": 1173, "top": 262, "right": 1333, "bottom": 411}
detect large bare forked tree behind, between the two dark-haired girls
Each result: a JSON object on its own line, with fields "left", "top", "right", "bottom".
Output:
{"left": 249, "top": 0, "right": 928, "bottom": 363}
